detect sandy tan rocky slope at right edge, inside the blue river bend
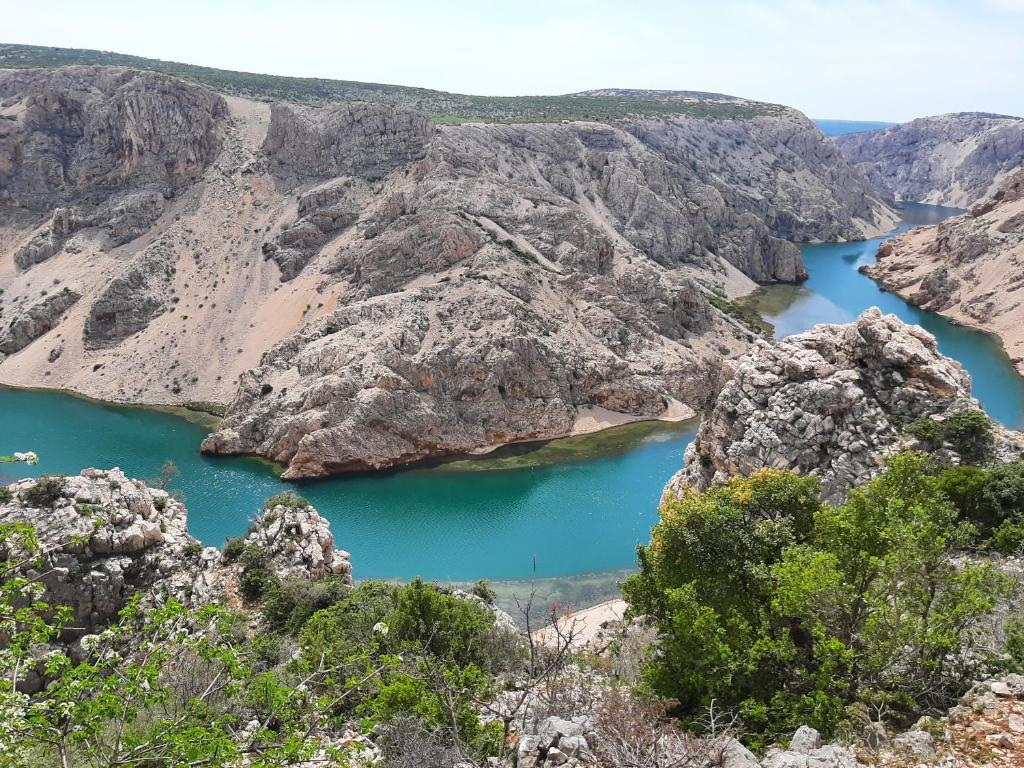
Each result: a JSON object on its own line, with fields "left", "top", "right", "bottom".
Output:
{"left": 864, "top": 169, "right": 1024, "bottom": 374}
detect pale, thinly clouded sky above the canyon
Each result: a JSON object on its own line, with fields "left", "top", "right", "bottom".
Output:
{"left": 0, "top": 0, "right": 1024, "bottom": 122}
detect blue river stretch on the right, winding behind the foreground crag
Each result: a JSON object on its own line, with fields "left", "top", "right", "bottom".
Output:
{"left": 753, "top": 203, "right": 1024, "bottom": 428}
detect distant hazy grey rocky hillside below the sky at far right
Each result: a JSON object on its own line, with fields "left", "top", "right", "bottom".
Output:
{"left": 834, "top": 113, "right": 1024, "bottom": 207}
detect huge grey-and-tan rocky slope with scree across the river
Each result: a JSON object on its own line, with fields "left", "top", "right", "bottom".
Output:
{"left": 0, "top": 67, "right": 893, "bottom": 477}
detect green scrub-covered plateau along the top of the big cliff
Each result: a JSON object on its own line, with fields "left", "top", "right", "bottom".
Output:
{"left": 0, "top": 43, "right": 786, "bottom": 123}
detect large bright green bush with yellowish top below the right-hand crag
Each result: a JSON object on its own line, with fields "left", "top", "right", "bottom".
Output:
{"left": 624, "top": 454, "right": 1011, "bottom": 744}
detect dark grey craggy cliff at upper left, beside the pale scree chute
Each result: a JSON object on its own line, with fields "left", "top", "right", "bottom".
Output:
{"left": 0, "top": 67, "right": 226, "bottom": 210}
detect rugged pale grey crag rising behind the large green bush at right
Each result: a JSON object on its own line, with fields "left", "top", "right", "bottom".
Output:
{"left": 666, "top": 307, "right": 977, "bottom": 501}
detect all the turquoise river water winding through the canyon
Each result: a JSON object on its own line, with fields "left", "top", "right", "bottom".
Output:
{"left": 0, "top": 206, "right": 1024, "bottom": 581}
